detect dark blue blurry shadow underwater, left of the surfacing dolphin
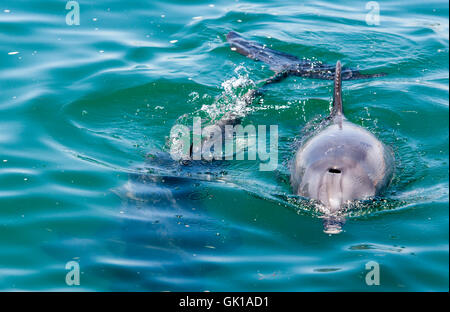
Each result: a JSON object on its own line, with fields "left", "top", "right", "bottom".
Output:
{"left": 110, "top": 153, "right": 239, "bottom": 291}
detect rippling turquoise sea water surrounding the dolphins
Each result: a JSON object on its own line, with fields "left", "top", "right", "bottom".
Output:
{"left": 0, "top": 0, "right": 449, "bottom": 291}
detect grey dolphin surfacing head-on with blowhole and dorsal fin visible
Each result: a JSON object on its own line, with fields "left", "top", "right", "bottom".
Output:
{"left": 291, "top": 61, "right": 394, "bottom": 233}
